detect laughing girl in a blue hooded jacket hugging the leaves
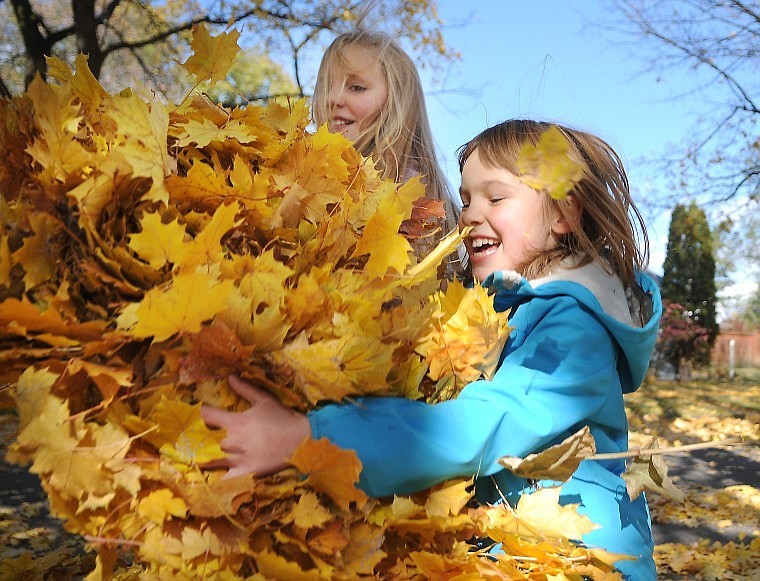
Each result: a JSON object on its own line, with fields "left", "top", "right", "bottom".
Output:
{"left": 203, "top": 121, "right": 662, "bottom": 581}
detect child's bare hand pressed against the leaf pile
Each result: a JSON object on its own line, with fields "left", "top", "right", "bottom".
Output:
{"left": 201, "top": 375, "right": 311, "bottom": 478}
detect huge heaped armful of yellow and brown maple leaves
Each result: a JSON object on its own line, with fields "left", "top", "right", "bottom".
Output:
{"left": 0, "top": 24, "right": 628, "bottom": 579}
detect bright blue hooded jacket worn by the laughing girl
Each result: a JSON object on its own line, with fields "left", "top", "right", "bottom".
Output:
{"left": 309, "top": 263, "right": 662, "bottom": 581}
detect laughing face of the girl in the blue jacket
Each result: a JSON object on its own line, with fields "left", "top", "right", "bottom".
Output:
{"left": 459, "top": 149, "right": 567, "bottom": 281}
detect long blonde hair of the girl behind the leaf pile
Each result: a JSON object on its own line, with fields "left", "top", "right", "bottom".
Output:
{"left": 312, "top": 30, "right": 456, "bottom": 232}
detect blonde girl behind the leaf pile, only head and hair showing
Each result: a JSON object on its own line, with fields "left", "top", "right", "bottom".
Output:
{"left": 312, "top": 31, "right": 456, "bottom": 249}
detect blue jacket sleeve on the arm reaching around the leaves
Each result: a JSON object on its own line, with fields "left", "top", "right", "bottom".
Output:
{"left": 309, "top": 297, "right": 625, "bottom": 497}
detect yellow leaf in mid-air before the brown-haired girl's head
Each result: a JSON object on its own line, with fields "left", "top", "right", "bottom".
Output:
{"left": 517, "top": 125, "right": 583, "bottom": 199}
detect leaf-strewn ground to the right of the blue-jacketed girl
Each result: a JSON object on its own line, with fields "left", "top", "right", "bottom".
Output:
{"left": 626, "top": 373, "right": 760, "bottom": 580}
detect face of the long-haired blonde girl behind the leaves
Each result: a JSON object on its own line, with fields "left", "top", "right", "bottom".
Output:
{"left": 327, "top": 45, "right": 388, "bottom": 141}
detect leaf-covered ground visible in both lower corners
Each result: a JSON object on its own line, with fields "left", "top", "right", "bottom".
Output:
{"left": 0, "top": 374, "right": 760, "bottom": 580}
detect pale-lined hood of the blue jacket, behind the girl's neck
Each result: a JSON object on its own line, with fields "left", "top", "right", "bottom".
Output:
{"left": 483, "top": 262, "right": 662, "bottom": 393}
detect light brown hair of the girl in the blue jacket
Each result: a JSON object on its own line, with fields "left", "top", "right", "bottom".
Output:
{"left": 458, "top": 119, "right": 649, "bottom": 285}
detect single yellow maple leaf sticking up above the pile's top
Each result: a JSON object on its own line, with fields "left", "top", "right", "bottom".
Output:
{"left": 182, "top": 23, "right": 240, "bottom": 87}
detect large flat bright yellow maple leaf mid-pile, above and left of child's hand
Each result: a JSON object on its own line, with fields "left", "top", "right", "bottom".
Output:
{"left": 116, "top": 271, "right": 235, "bottom": 341}
